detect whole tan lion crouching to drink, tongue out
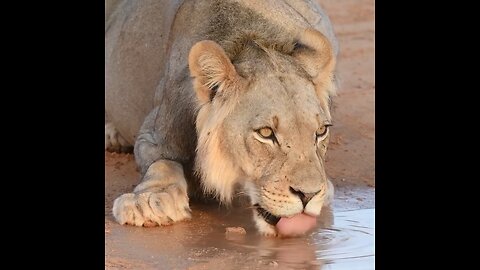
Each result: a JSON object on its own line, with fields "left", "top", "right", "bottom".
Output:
{"left": 105, "top": 0, "right": 338, "bottom": 236}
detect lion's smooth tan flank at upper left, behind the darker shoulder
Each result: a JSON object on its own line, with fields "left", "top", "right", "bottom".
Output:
{"left": 105, "top": 0, "right": 183, "bottom": 144}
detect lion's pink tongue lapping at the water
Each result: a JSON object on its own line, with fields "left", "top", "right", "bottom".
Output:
{"left": 276, "top": 213, "right": 317, "bottom": 236}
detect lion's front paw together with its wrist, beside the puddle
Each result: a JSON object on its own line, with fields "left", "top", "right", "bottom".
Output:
{"left": 113, "top": 159, "right": 191, "bottom": 227}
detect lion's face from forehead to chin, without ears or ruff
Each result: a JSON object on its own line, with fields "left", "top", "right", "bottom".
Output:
{"left": 227, "top": 73, "right": 331, "bottom": 234}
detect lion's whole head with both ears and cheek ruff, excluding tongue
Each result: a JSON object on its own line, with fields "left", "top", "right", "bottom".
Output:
{"left": 189, "top": 29, "right": 335, "bottom": 235}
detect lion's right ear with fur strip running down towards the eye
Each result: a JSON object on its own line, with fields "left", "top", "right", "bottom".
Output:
{"left": 292, "top": 28, "right": 336, "bottom": 118}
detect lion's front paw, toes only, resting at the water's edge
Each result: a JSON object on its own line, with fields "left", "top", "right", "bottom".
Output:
{"left": 113, "top": 185, "right": 191, "bottom": 227}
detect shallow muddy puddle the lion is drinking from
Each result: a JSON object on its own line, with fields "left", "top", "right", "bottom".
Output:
{"left": 106, "top": 204, "right": 375, "bottom": 270}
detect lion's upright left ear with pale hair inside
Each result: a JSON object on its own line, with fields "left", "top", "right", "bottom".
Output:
{"left": 188, "top": 40, "right": 239, "bottom": 103}
